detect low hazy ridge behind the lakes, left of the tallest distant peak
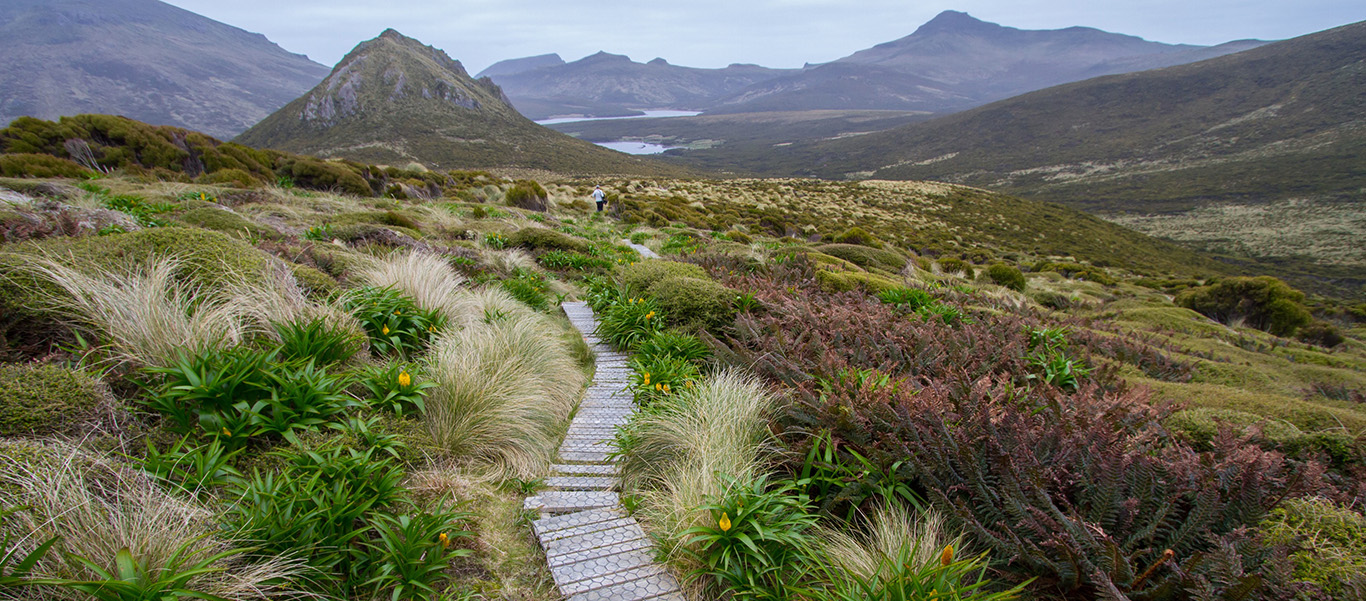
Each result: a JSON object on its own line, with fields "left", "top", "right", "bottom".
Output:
{"left": 479, "top": 52, "right": 796, "bottom": 119}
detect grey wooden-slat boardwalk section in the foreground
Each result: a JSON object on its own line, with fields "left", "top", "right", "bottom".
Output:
{"left": 526, "top": 302, "right": 683, "bottom": 601}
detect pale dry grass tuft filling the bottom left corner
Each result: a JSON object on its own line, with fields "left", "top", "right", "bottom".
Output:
{"left": 0, "top": 447, "right": 306, "bottom": 600}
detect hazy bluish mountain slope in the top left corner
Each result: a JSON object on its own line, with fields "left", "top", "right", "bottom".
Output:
{"left": 0, "top": 0, "right": 328, "bottom": 138}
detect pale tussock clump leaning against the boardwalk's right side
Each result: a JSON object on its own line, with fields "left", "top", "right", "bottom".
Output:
{"left": 622, "top": 370, "right": 779, "bottom": 553}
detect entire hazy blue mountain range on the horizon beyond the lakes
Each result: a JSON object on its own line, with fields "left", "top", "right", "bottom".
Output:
{"left": 481, "top": 11, "right": 1266, "bottom": 119}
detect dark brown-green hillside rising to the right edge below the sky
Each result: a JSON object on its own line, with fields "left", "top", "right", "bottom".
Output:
{"left": 743, "top": 22, "right": 1366, "bottom": 212}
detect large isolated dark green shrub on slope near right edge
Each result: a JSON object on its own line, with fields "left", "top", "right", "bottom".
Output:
{"left": 1176, "top": 276, "right": 1313, "bottom": 336}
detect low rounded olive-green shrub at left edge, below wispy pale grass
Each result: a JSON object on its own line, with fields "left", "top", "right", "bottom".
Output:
{"left": 0, "top": 363, "right": 108, "bottom": 436}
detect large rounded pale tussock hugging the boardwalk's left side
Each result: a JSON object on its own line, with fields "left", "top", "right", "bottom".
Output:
{"left": 426, "top": 317, "right": 583, "bottom": 478}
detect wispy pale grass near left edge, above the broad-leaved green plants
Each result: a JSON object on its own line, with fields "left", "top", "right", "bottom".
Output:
{"left": 16, "top": 255, "right": 251, "bottom": 365}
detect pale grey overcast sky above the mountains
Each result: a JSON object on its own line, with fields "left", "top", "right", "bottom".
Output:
{"left": 167, "top": 0, "right": 1366, "bottom": 74}
